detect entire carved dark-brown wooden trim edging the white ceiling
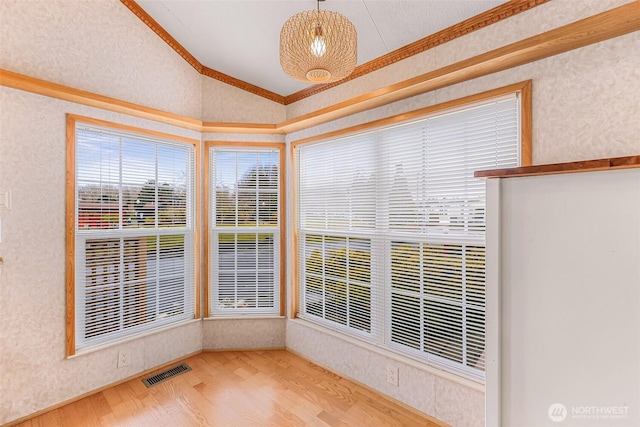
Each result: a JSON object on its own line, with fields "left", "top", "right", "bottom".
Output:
{"left": 120, "top": 0, "right": 550, "bottom": 105}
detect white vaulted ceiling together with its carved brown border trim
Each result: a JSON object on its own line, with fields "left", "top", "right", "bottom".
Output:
{"left": 121, "top": 0, "right": 547, "bottom": 104}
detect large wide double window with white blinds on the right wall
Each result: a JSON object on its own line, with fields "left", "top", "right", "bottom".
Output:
{"left": 295, "top": 88, "right": 521, "bottom": 379}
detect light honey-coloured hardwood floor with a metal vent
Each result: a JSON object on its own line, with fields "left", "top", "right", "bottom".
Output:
{"left": 13, "top": 350, "right": 446, "bottom": 427}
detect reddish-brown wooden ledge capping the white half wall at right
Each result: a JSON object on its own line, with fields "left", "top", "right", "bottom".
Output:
{"left": 474, "top": 155, "right": 640, "bottom": 178}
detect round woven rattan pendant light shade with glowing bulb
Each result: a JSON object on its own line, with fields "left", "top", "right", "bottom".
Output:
{"left": 280, "top": 10, "right": 358, "bottom": 83}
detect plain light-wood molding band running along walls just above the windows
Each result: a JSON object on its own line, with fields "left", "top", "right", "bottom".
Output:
{"left": 0, "top": 0, "right": 640, "bottom": 134}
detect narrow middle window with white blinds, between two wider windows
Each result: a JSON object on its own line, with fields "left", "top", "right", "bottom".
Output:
{"left": 207, "top": 143, "right": 284, "bottom": 316}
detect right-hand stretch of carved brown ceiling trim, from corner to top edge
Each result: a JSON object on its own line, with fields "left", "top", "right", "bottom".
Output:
{"left": 284, "top": 0, "right": 550, "bottom": 105}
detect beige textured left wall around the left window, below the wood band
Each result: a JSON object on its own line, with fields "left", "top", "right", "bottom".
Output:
{"left": 0, "top": 87, "right": 202, "bottom": 424}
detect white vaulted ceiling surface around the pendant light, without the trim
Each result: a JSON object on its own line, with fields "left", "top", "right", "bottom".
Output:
{"left": 132, "top": 0, "right": 507, "bottom": 96}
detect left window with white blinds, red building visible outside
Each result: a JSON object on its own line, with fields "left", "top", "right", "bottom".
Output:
{"left": 67, "top": 116, "right": 197, "bottom": 354}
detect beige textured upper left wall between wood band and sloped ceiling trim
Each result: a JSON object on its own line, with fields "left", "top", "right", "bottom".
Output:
{"left": 0, "top": 0, "right": 201, "bottom": 118}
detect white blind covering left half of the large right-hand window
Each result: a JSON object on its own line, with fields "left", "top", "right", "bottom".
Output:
{"left": 298, "top": 135, "right": 382, "bottom": 339}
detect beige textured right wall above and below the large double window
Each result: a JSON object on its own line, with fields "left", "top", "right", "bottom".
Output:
{"left": 286, "top": 0, "right": 640, "bottom": 427}
